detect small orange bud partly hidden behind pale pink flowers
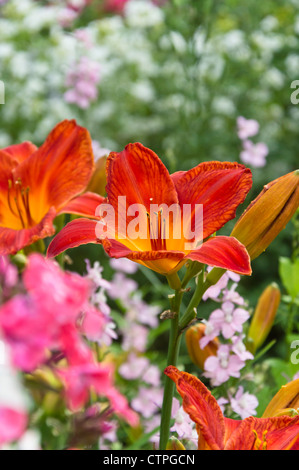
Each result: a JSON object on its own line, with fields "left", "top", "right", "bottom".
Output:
{"left": 186, "top": 323, "right": 219, "bottom": 370}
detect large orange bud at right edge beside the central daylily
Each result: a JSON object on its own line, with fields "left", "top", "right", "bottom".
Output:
{"left": 231, "top": 170, "right": 299, "bottom": 260}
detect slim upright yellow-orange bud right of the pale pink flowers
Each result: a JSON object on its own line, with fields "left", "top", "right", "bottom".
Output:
{"left": 247, "top": 282, "right": 280, "bottom": 353}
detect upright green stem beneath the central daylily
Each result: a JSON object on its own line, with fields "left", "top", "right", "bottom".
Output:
{"left": 159, "top": 290, "right": 183, "bottom": 450}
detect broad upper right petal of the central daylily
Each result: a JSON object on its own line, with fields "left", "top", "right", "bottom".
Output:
{"left": 173, "top": 162, "right": 252, "bottom": 239}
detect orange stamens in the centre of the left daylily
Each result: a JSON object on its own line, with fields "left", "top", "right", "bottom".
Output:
{"left": 7, "top": 178, "right": 34, "bottom": 228}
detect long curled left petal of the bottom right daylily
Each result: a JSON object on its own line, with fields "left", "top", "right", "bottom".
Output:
{"left": 164, "top": 366, "right": 225, "bottom": 450}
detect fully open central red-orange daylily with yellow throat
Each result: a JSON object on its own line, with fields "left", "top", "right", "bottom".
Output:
{"left": 48, "top": 143, "right": 252, "bottom": 274}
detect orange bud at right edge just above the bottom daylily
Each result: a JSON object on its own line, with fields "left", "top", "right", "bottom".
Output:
{"left": 263, "top": 379, "right": 299, "bottom": 418}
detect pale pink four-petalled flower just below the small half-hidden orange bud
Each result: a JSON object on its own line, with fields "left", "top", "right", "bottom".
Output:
{"left": 204, "top": 344, "right": 245, "bottom": 387}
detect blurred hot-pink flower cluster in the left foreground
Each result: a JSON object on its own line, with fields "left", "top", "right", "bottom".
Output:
{"left": 0, "top": 254, "right": 137, "bottom": 448}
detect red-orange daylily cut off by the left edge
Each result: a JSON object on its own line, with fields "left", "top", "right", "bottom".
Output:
{"left": 0, "top": 121, "right": 103, "bottom": 255}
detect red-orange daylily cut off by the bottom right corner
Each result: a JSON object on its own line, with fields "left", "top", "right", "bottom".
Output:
{"left": 165, "top": 366, "right": 299, "bottom": 450}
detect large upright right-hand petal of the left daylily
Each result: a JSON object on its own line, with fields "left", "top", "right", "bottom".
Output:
{"left": 15, "top": 121, "right": 94, "bottom": 220}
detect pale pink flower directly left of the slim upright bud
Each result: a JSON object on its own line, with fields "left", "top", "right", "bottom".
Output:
{"left": 209, "top": 302, "right": 249, "bottom": 339}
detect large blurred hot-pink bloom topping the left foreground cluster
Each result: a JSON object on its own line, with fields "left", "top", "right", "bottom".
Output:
{"left": 0, "top": 254, "right": 95, "bottom": 372}
